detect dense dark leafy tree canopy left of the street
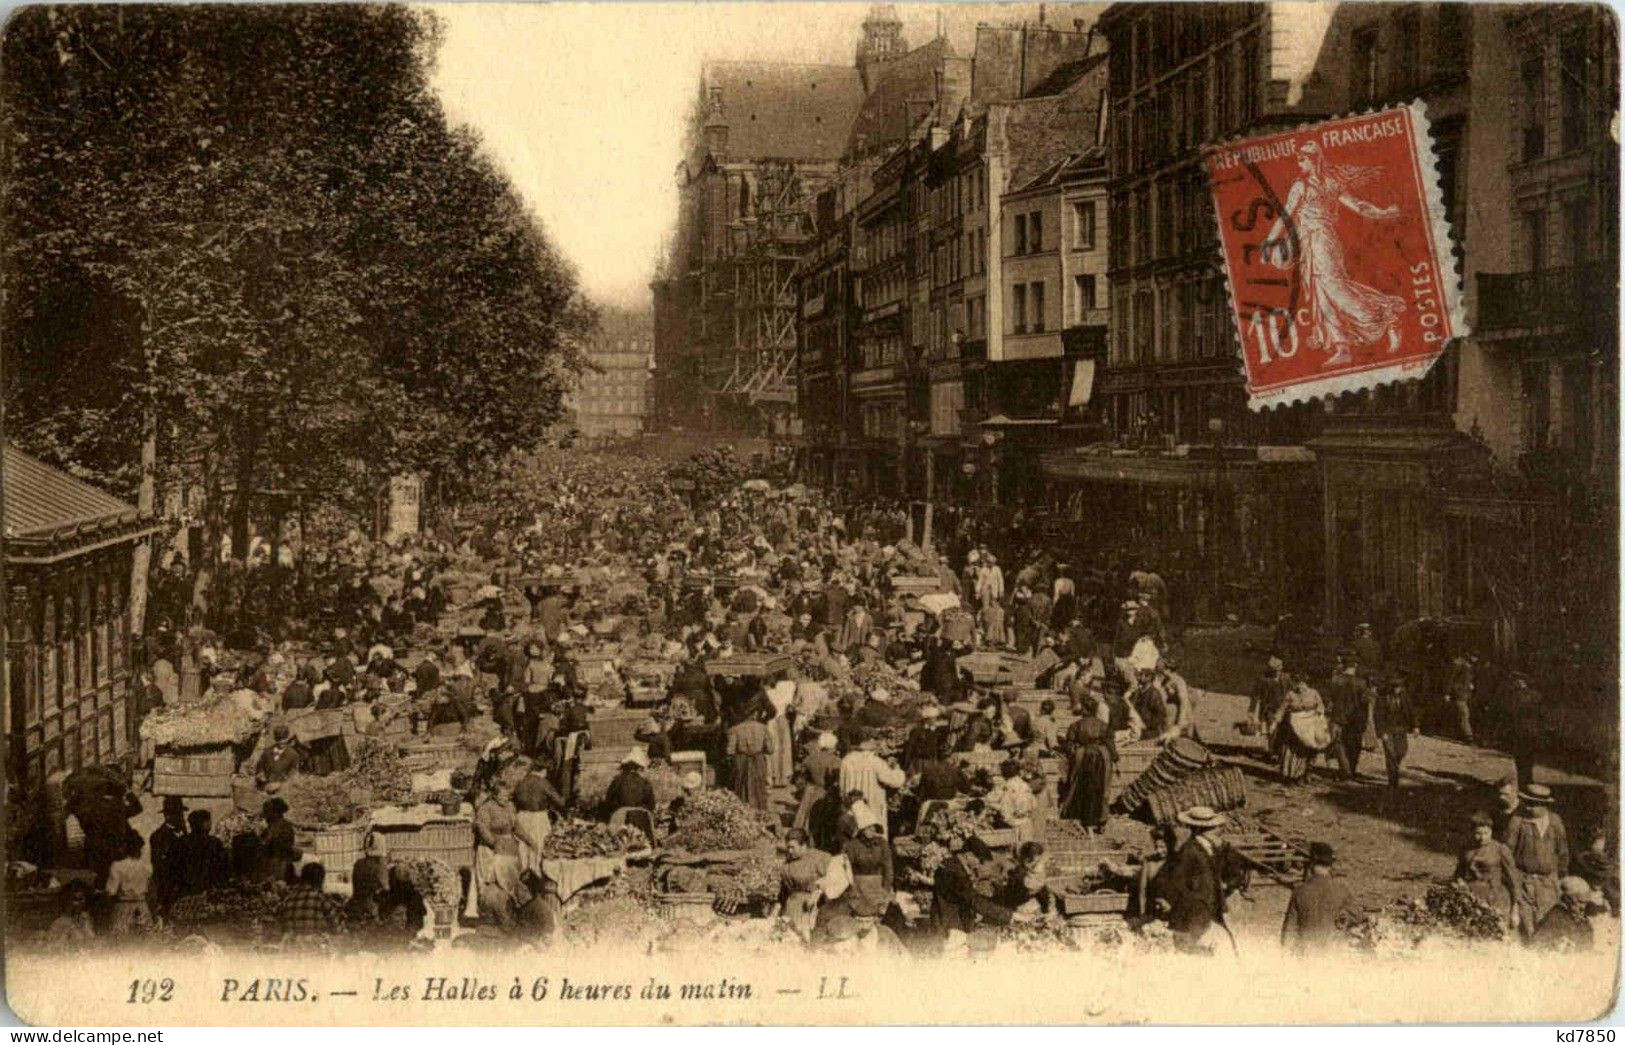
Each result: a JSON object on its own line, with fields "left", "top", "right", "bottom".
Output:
{"left": 0, "top": 5, "right": 595, "bottom": 617}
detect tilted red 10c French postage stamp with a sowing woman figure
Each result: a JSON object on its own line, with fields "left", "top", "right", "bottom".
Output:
{"left": 1203, "top": 102, "right": 1467, "bottom": 410}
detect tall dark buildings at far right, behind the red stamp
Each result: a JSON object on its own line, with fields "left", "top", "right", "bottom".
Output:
{"left": 1072, "top": 3, "right": 1619, "bottom": 682}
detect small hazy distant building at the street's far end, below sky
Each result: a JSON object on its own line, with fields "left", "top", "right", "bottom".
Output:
{"left": 566, "top": 310, "right": 655, "bottom": 439}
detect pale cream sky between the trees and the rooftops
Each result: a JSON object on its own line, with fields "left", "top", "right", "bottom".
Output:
{"left": 432, "top": 2, "right": 1077, "bottom": 307}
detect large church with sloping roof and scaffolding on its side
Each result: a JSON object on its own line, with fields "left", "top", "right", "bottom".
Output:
{"left": 652, "top": 57, "right": 884, "bottom": 436}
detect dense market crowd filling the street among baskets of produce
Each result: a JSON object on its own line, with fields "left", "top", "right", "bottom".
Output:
{"left": 22, "top": 455, "right": 1617, "bottom": 949}
